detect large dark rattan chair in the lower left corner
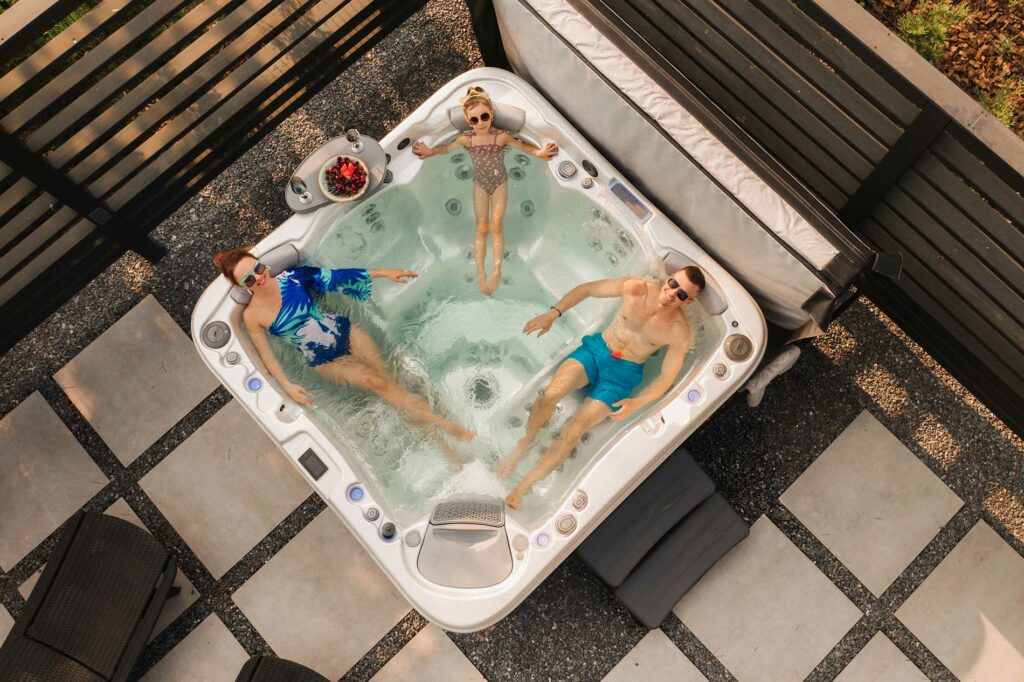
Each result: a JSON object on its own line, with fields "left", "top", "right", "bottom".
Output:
{"left": 0, "top": 513, "right": 175, "bottom": 682}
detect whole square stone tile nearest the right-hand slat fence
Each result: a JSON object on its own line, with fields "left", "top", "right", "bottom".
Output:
{"left": 779, "top": 411, "right": 964, "bottom": 596}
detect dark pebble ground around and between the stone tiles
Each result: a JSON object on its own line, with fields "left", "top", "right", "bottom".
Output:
{"left": 0, "top": 0, "right": 1024, "bottom": 682}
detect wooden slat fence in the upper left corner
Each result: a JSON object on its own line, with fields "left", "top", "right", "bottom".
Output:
{"left": 0, "top": 0, "right": 425, "bottom": 352}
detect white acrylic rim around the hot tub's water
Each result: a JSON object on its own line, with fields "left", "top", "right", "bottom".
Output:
{"left": 191, "top": 69, "right": 765, "bottom": 632}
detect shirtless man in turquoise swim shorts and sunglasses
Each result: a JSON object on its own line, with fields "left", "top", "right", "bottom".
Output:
{"left": 498, "top": 265, "right": 705, "bottom": 509}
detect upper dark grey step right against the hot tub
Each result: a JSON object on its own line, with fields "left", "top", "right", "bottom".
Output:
{"left": 577, "top": 447, "right": 715, "bottom": 587}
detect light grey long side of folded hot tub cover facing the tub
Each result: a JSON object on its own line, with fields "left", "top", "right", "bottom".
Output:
{"left": 495, "top": 0, "right": 823, "bottom": 330}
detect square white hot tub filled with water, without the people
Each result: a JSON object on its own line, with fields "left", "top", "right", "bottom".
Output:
{"left": 193, "top": 69, "right": 765, "bottom": 632}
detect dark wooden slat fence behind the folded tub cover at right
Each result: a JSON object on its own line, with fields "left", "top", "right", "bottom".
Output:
{"left": 570, "top": 0, "right": 1024, "bottom": 433}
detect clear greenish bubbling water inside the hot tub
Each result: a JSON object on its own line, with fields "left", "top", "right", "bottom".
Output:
{"left": 272, "top": 155, "right": 709, "bottom": 525}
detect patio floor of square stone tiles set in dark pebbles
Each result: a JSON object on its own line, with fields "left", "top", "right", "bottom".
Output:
{"left": 0, "top": 0, "right": 1024, "bottom": 682}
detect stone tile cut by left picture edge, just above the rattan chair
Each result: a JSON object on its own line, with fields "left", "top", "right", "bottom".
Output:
{"left": 0, "top": 392, "right": 106, "bottom": 569}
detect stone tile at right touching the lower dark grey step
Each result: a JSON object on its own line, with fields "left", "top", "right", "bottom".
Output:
{"left": 673, "top": 516, "right": 860, "bottom": 682}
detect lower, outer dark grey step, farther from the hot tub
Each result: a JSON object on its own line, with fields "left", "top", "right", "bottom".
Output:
{"left": 615, "top": 493, "right": 750, "bottom": 628}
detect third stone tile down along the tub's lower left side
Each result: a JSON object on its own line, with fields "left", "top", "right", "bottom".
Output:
{"left": 233, "top": 510, "right": 409, "bottom": 680}
